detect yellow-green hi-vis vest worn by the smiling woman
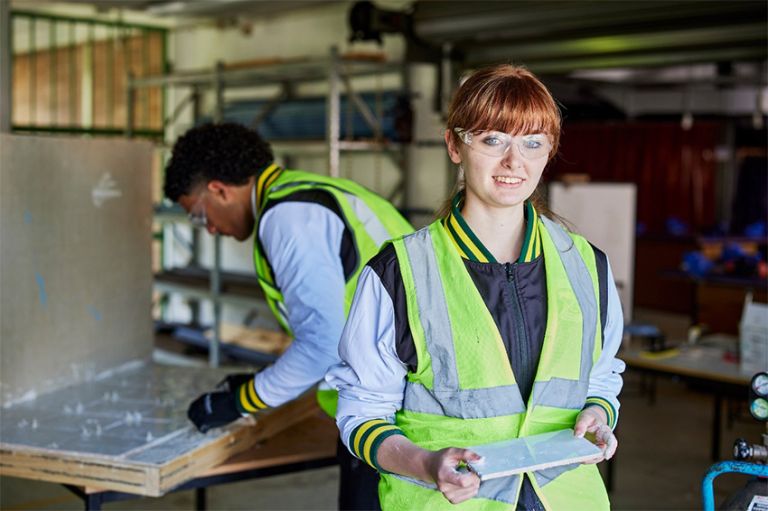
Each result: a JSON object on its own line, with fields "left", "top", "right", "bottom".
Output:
{"left": 379, "top": 216, "right": 609, "bottom": 511}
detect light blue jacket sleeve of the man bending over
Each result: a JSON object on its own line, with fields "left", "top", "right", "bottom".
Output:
{"left": 255, "top": 202, "right": 346, "bottom": 406}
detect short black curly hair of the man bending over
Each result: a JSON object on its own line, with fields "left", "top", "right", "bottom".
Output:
{"left": 164, "top": 123, "right": 274, "bottom": 202}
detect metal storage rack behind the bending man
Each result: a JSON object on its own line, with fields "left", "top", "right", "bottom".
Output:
{"left": 125, "top": 47, "right": 410, "bottom": 367}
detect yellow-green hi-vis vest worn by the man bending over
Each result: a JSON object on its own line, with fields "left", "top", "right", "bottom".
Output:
{"left": 253, "top": 169, "right": 413, "bottom": 416}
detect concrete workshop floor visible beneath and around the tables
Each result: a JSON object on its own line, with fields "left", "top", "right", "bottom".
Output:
{"left": 0, "top": 310, "right": 766, "bottom": 510}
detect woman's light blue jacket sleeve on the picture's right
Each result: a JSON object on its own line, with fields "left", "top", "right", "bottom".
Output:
{"left": 587, "top": 262, "right": 626, "bottom": 425}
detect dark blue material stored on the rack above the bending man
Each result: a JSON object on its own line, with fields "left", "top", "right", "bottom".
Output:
{"left": 207, "top": 91, "right": 412, "bottom": 142}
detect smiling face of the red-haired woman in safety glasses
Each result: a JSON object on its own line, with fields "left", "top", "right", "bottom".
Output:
{"left": 445, "top": 131, "right": 551, "bottom": 212}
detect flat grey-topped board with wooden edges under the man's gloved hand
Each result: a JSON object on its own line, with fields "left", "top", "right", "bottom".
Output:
{"left": 0, "top": 363, "right": 318, "bottom": 496}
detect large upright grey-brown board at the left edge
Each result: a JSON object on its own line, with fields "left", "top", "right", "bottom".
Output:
{"left": 0, "top": 135, "right": 152, "bottom": 405}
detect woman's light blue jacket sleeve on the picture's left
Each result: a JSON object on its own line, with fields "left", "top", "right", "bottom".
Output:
{"left": 326, "top": 266, "right": 408, "bottom": 452}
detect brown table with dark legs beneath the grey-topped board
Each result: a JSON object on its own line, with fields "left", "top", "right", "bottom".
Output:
{"left": 65, "top": 412, "right": 338, "bottom": 511}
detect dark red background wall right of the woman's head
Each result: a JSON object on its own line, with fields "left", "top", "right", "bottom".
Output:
{"left": 544, "top": 121, "right": 721, "bottom": 234}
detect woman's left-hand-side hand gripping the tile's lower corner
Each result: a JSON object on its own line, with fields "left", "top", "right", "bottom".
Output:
{"left": 427, "top": 447, "right": 481, "bottom": 504}
